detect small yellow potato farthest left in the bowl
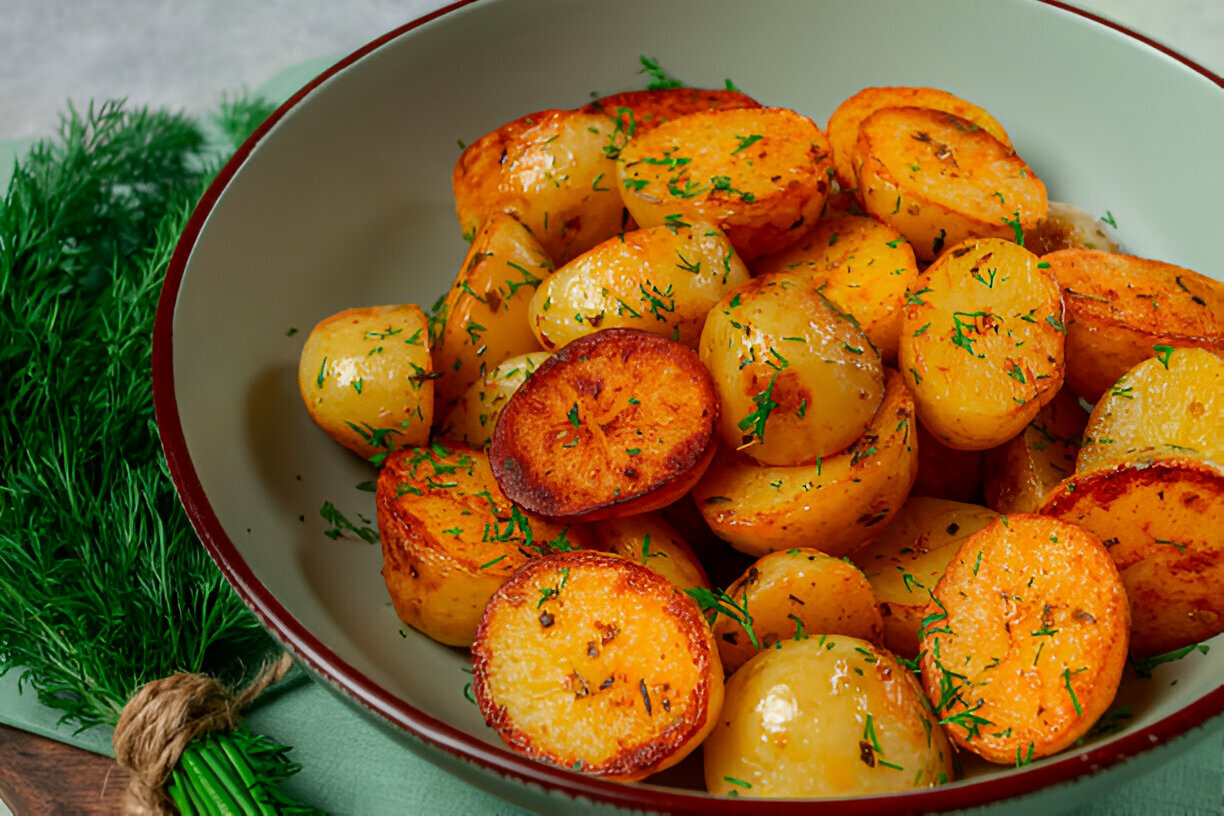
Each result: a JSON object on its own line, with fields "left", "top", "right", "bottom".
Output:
{"left": 297, "top": 303, "right": 433, "bottom": 462}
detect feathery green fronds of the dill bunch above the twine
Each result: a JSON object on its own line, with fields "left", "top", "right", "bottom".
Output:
{"left": 0, "top": 100, "right": 271, "bottom": 729}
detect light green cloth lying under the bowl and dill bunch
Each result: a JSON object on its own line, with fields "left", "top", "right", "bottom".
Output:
{"left": 0, "top": 48, "right": 1224, "bottom": 816}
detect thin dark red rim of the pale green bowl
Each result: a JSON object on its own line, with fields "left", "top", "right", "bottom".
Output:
{"left": 152, "top": 0, "right": 1224, "bottom": 815}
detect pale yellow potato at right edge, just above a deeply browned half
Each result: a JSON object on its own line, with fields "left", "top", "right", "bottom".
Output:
{"left": 1067, "top": 349, "right": 1224, "bottom": 476}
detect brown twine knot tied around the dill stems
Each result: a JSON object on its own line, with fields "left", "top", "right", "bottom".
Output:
{"left": 113, "top": 652, "right": 293, "bottom": 815}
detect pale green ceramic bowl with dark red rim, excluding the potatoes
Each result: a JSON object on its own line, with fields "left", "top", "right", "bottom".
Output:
{"left": 154, "top": 0, "right": 1224, "bottom": 814}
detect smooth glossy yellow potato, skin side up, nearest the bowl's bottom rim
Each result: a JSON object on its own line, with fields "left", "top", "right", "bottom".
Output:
{"left": 704, "top": 635, "right": 953, "bottom": 798}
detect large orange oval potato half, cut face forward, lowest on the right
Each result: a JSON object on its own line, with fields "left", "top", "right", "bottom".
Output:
{"left": 919, "top": 514, "right": 1130, "bottom": 765}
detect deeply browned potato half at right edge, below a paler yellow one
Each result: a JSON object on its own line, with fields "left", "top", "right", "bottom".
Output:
{"left": 1042, "top": 453, "right": 1224, "bottom": 657}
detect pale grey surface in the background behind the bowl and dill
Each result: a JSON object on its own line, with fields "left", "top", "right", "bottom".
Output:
{"left": 0, "top": 0, "right": 1224, "bottom": 141}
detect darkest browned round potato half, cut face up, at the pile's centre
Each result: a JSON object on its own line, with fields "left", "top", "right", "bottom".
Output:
{"left": 488, "top": 329, "right": 718, "bottom": 521}
